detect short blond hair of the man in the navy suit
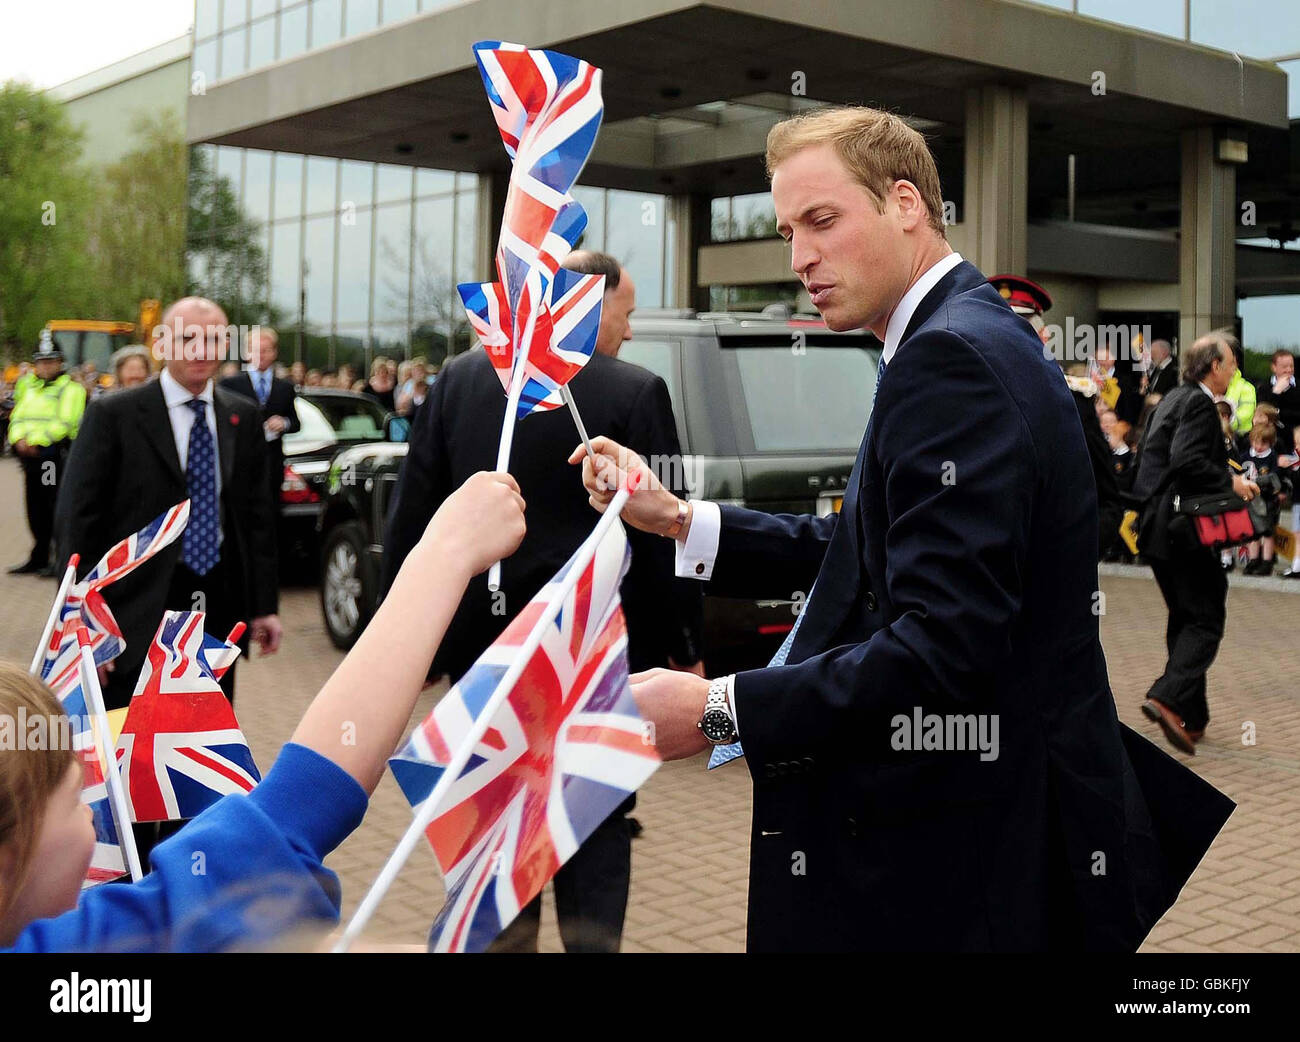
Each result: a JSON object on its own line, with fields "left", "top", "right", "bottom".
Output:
{"left": 767, "top": 107, "right": 948, "bottom": 239}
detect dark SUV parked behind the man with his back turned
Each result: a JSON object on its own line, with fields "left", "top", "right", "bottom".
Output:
{"left": 320, "top": 312, "right": 880, "bottom": 674}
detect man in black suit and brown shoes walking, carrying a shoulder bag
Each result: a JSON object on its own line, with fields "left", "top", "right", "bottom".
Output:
{"left": 1134, "top": 333, "right": 1260, "bottom": 756}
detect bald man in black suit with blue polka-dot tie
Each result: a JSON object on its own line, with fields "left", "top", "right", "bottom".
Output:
{"left": 56, "top": 298, "right": 281, "bottom": 708}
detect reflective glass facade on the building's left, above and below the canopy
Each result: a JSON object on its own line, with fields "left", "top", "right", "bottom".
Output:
{"left": 190, "top": 0, "right": 675, "bottom": 369}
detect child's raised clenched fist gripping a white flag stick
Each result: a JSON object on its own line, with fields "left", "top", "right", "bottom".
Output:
{"left": 420, "top": 470, "right": 525, "bottom": 577}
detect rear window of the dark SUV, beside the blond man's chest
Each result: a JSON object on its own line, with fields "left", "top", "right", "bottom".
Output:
{"left": 733, "top": 344, "right": 876, "bottom": 452}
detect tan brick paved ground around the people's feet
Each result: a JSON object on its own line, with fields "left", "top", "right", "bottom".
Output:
{"left": 0, "top": 459, "right": 1300, "bottom": 951}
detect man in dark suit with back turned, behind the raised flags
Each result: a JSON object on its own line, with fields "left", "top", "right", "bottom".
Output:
{"left": 384, "top": 251, "right": 703, "bottom": 952}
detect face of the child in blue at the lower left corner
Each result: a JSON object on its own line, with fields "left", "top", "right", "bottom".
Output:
{"left": 8, "top": 763, "right": 95, "bottom": 932}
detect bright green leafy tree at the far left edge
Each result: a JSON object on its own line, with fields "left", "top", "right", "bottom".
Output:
{"left": 0, "top": 83, "right": 94, "bottom": 357}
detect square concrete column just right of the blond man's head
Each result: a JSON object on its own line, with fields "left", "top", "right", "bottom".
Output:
{"left": 962, "top": 84, "right": 1030, "bottom": 275}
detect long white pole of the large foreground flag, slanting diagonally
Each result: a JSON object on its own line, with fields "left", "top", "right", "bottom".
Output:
{"left": 333, "top": 481, "right": 640, "bottom": 954}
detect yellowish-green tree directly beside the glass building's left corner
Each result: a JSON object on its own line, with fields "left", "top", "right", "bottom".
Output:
{"left": 90, "top": 110, "right": 187, "bottom": 322}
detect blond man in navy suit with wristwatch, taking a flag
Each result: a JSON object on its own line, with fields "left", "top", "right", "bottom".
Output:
{"left": 571, "top": 109, "right": 1232, "bottom": 951}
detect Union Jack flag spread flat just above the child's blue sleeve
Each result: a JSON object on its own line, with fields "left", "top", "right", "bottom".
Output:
{"left": 117, "top": 612, "right": 261, "bottom": 821}
